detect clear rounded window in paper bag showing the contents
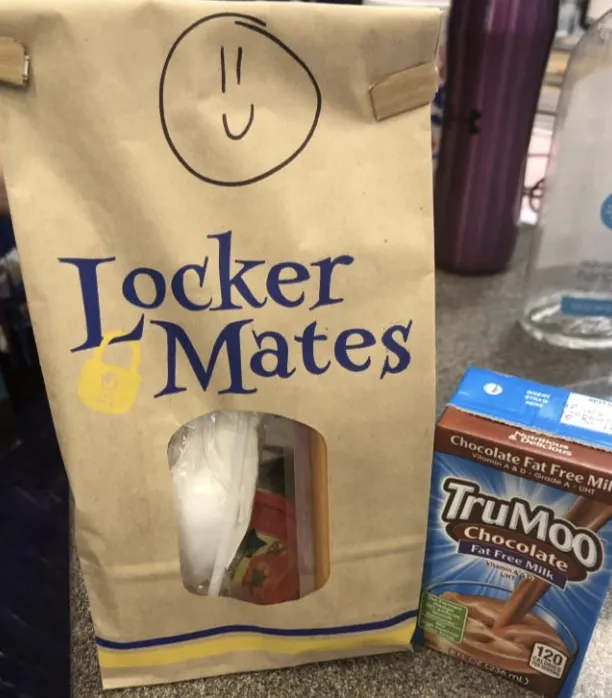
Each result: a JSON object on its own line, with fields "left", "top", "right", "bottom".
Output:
{"left": 168, "top": 411, "right": 330, "bottom": 605}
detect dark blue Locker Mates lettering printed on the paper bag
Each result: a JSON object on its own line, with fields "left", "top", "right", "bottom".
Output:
{"left": 58, "top": 231, "right": 412, "bottom": 398}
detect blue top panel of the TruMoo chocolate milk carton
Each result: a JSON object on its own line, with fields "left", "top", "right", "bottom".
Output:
{"left": 449, "top": 368, "right": 612, "bottom": 451}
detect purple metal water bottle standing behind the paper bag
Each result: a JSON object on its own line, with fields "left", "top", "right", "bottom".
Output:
{"left": 434, "top": 0, "right": 559, "bottom": 274}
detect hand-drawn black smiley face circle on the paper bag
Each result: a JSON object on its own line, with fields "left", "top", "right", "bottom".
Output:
{"left": 159, "top": 12, "right": 321, "bottom": 187}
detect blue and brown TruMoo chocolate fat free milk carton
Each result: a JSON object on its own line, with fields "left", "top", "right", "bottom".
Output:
{"left": 416, "top": 369, "right": 612, "bottom": 698}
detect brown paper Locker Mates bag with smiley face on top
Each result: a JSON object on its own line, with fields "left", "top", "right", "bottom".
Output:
{"left": 0, "top": 0, "right": 439, "bottom": 688}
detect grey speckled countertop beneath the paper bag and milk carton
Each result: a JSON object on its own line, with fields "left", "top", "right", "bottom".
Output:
{"left": 72, "top": 230, "right": 612, "bottom": 698}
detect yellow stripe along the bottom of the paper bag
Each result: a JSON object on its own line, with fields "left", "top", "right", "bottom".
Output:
{"left": 98, "top": 619, "right": 416, "bottom": 669}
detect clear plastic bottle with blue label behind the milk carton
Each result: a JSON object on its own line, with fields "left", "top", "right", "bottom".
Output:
{"left": 521, "top": 12, "right": 612, "bottom": 349}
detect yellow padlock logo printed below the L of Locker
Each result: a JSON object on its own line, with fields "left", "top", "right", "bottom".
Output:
{"left": 77, "top": 332, "right": 142, "bottom": 414}
